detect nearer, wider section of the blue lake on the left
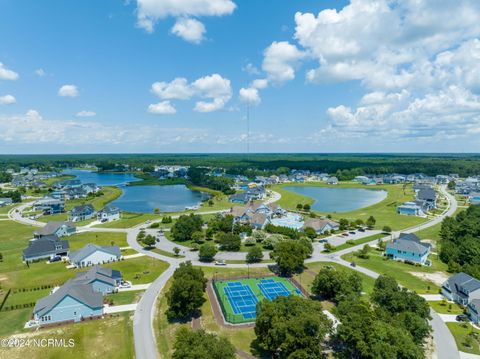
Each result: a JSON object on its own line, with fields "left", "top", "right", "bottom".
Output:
{"left": 112, "top": 184, "right": 208, "bottom": 213}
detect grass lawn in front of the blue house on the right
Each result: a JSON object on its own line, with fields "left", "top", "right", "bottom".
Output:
{"left": 342, "top": 251, "right": 446, "bottom": 294}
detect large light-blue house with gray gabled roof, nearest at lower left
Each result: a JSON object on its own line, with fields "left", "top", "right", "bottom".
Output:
{"left": 33, "top": 279, "right": 103, "bottom": 326}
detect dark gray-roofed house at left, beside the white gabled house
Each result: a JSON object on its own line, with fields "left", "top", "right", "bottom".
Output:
{"left": 23, "top": 235, "right": 69, "bottom": 262}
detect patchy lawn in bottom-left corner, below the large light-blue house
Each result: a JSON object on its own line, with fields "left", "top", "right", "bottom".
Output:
{"left": 0, "top": 313, "right": 135, "bottom": 359}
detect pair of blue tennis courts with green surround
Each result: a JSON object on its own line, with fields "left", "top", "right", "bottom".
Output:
{"left": 213, "top": 277, "right": 302, "bottom": 324}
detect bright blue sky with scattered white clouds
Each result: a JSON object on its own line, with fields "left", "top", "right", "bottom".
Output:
{"left": 0, "top": 0, "right": 480, "bottom": 153}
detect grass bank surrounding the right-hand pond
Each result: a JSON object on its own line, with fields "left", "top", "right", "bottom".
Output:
{"left": 271, "top": 182, "right": 426, "bottom": 230}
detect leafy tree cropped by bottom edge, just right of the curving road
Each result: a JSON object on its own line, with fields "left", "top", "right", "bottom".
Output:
{"left": 172, "top": 327, "right": 235, "bottom": 359}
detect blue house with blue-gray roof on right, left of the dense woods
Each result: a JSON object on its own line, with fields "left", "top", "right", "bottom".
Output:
{"left": 385, "top": 233, "right": 430, "bottom": 265}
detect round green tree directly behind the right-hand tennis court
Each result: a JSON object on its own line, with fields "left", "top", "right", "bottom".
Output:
{"left": 270, "top": 240, "right": 307, "bottom": 276}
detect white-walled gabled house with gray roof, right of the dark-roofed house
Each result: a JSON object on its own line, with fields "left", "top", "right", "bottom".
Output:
{"left": 68, "top": 243, "right": 122, "bottom": 267}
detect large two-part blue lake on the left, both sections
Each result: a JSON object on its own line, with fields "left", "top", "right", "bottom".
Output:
{"left": 63, "top": 170, "right": 209, "bottom": 213}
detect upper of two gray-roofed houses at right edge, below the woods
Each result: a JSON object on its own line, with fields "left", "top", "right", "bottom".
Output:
{"left": 442, "top": 272, "right": 480, "bottom": 305}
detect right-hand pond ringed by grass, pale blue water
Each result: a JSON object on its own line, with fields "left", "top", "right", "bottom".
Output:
{"left": 284, "top": 186, "right": 387, "bottom": 212}
